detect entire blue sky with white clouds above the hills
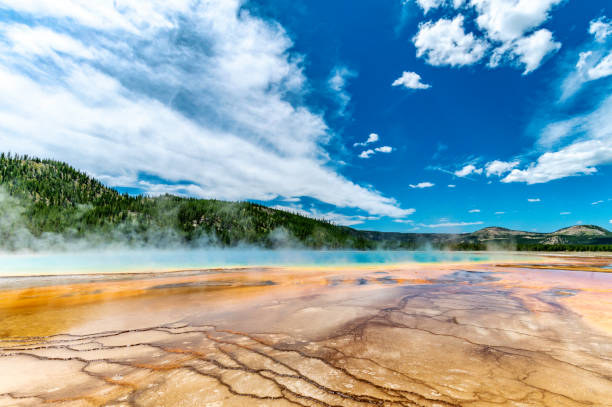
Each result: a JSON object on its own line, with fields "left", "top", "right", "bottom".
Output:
{"left": 0, "top": 0, "right": 612, "bottom": 233}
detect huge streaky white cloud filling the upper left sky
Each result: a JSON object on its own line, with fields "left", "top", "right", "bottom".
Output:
{"left": 0, "top": 0, "right": 410, "bottom": 217}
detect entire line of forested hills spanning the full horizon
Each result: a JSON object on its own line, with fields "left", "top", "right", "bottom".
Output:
{"left": 0, "top": 153, "right": 612, "bottom": 251}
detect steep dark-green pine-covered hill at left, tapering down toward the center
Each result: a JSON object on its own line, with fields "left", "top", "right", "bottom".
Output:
{"left": 0, "top": 154, "right": 373, "bottom": 249}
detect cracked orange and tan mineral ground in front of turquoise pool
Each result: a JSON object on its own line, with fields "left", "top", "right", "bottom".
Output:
{"left": 0, "top": 257, "right": 612, "bottom": 407}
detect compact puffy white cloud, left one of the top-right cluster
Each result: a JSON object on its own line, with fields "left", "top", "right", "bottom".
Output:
{"left": 412, "top": 15, "right": 489, "bottom": 66}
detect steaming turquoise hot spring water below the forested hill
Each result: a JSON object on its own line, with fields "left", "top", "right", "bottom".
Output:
{"left": 0, "top": 249, "right": 536, "bottom": 276}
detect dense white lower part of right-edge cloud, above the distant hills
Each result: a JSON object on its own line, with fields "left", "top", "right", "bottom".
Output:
{"left": 502, "top": 92, "right": 612, "bottom": 184}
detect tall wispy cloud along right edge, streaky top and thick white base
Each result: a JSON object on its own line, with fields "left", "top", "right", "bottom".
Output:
{"left": 502, "top": 17, "right": 612, "bottom": 184}
